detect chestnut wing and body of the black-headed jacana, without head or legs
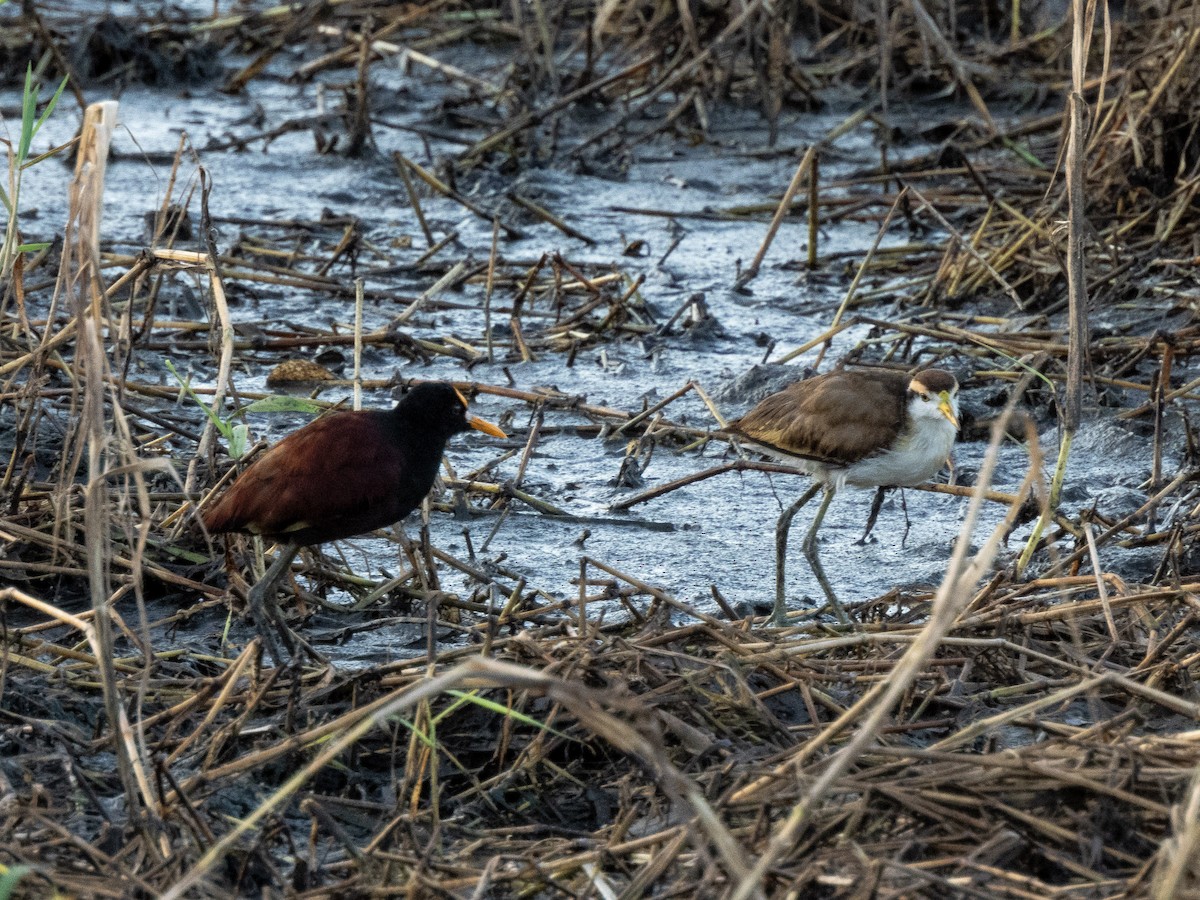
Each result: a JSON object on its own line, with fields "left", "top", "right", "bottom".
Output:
{"left": 204, "top": 412, "right": 417, "bottom": 544}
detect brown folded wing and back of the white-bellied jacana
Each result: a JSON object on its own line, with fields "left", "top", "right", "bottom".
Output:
{"left": 730, "top": 372, "right": 910, "bottom": 466}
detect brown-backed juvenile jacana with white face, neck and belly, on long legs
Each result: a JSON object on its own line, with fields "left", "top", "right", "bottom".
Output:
{"left": 728, "top": 368, "right": 959, "bottom": 624}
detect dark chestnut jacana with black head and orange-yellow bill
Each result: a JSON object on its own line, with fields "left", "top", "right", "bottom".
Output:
{"left": 204, "top": 383, "right": 506, "bottom": 664}
